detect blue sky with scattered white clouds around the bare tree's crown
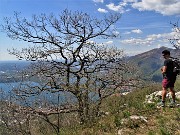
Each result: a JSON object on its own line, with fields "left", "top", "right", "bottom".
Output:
{"left": 0, "top": 0, "right": 180, "bottom": 61}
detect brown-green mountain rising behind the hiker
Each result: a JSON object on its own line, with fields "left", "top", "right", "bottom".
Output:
{"left": 129, "top": 47, "right": 180, "bottom": 82}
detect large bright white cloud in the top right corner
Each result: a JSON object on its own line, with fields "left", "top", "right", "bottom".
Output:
{"left": 132, "top": 0, "right": 180, "bottom": 15}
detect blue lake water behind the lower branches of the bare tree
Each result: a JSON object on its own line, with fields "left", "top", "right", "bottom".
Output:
{"left": 0, "top": 82, "right": 77, "bottom": 106}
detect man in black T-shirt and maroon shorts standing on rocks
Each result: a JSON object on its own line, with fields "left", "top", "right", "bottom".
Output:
{"left": 159, "top": 50, "right": 176, "bottom": 107}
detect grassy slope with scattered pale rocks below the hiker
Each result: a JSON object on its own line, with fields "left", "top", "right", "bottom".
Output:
{"left": 62, "top": 80, "right": 180, "bottom": 135}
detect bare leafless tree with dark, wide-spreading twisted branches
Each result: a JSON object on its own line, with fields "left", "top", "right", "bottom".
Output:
{"left": 3, "top": 10, "right": 137, "bottom": 132}
